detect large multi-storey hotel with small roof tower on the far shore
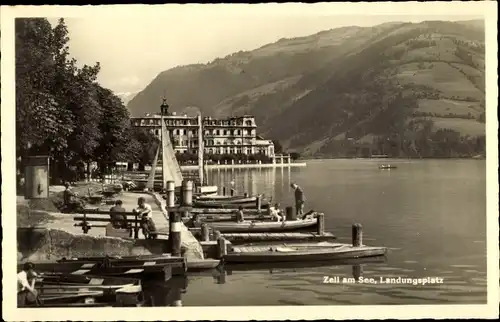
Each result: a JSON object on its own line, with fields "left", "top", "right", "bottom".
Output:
{"left": 132, "top": 113, "right": 275, "bottom": 159}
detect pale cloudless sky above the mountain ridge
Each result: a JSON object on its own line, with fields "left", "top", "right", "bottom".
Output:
{"left": 40, "top": 5, "right": 482, "bottom": 95}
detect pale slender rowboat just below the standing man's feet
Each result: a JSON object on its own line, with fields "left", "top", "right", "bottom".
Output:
{"left": 200, "top": 218, "right": 318, "bottom": 233}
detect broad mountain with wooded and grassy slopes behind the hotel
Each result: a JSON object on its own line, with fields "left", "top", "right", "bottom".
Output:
{"left": 128, "top": 20, "right": 485, "bottom": 156}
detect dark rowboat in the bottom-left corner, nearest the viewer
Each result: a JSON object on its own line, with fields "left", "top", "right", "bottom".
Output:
{"left": 21, "top": 273, "right": 143, "bottom": 307}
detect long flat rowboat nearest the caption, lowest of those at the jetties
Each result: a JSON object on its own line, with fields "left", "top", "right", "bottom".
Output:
{"left": 223, "top": 242, "right": 387, "bottom": 263}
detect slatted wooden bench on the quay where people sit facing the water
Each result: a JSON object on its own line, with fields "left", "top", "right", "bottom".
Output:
{"left": 73, "top": 209, "right": 141, "bottom": 238}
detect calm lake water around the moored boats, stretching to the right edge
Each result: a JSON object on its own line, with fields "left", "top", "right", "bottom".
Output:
{"left": 144, "top": 159, "right": 487, "bottom": 306}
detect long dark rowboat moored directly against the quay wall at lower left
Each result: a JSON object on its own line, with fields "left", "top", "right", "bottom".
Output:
{"left": 18, "top": 255, "right": 187, "bottom": 279}
